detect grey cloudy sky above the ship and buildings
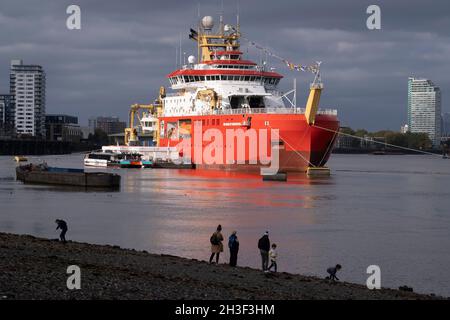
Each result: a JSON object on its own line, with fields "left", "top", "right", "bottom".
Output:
{"left": 0, "top": 0, "right": 450, "bottom": 130}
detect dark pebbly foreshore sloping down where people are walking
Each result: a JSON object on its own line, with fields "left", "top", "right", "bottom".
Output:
{"left": 0, "top": 233, "right": 443, "bottom": 300}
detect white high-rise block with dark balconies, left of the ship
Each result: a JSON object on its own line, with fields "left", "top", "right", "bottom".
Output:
{"left": 10, "top": 60, "right": 45, "bottom": 137}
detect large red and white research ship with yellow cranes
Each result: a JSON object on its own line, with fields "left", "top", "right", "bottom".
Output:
{"left": 118, "top": 16, "right": 339, "bottom": 172}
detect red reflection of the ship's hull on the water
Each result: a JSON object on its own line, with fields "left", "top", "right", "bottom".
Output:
{"left": 123, "top": 169, "right": 334, "bottom": 215}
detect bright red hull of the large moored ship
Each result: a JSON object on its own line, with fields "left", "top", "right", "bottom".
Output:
{"left": 159, "top": 113, "right": 339, "bottom": 172}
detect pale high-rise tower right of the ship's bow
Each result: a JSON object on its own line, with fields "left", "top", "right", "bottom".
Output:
{"left": 408, "top": 78, "right": 441, "bottom": 146}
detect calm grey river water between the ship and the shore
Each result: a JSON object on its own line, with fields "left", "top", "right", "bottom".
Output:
{"left": 0, "top": 154, "right": 450, "bottom": 296}
